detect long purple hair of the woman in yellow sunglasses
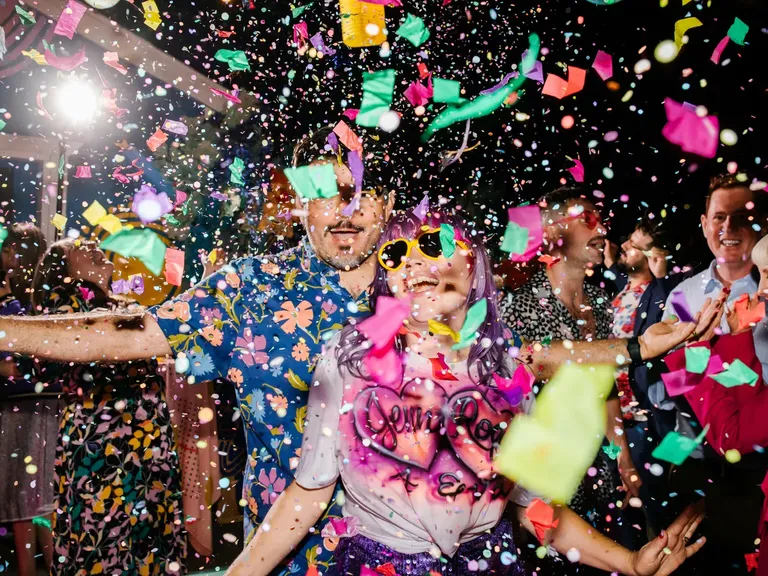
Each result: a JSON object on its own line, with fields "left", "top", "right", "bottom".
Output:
{"left": 337, "top": 211, "right": 511, "bottom": 384}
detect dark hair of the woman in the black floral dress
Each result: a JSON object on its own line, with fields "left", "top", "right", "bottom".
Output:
{"left": 32, "top": 238, "right": 112, "bottom": 314}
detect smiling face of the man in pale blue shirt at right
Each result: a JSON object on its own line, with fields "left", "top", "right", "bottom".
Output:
{"left": 701, "top": 187, "right": 758, "bottom": 264}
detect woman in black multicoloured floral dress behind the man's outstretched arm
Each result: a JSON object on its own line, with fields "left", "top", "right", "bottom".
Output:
{"left": 34, "top": 240, "right": 186, "bottom": 576}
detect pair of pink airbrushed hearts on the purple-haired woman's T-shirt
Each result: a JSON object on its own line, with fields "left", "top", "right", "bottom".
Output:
{"left": 353, "top": 383, "right": 512, "bottom": 472}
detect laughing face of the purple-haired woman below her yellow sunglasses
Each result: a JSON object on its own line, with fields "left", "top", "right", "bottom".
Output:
{"left": 387, "top": 231, "right": 474, "bottom": 326}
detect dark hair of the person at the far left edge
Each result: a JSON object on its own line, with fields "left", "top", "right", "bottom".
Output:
{"left": 2, "top": 222, "right": 46, "bottom": 308}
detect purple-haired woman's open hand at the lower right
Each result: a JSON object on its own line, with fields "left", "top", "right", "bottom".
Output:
{"left": 632, "top": 505, "right": 706, "bottom": 576}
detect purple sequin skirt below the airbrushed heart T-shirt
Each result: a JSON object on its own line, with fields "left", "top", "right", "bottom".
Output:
{"left": 330, "top": 520, "right": 525, "bottom": 576}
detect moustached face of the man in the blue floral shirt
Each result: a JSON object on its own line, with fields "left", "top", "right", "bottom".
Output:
{"left": 297, "top": 161, "right": 394, "bottom": 271}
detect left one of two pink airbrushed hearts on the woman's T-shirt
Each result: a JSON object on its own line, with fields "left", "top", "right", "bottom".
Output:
{"left": 353, "top": 384, "right": 447, "bottom": 470}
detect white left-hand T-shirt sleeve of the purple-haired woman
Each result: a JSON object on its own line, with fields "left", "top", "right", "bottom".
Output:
{"left": 294, "top": 345, "right": 343, "bottom": 490}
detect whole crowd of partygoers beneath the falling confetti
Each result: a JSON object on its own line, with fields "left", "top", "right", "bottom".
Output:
{"left": 0, "top": 128, "right": 768, "bottom": 576}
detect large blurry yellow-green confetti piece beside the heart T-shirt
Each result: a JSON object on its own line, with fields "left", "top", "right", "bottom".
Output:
{"left": 494, "top": 364, "right": 613, "bottom": 503}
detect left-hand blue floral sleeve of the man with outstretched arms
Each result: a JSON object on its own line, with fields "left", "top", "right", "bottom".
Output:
{"left": 150, "top": 262, "right": 250, "bottom": 380}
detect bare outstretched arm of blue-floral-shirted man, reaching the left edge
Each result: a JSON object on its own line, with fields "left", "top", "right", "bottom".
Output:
{"left": 0, "top": 312, "right": 171, "bottom": 362}
